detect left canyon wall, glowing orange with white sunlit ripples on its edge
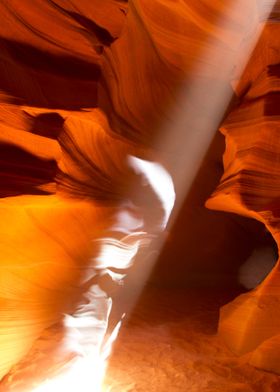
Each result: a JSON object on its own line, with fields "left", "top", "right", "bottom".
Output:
{"left": 0, "top": 1, "right": 174, "bottom": 392}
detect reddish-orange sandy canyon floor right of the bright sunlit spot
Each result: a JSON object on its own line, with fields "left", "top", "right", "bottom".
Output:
{"left": 106, "top": 289, "right": 280, "bottom": 392}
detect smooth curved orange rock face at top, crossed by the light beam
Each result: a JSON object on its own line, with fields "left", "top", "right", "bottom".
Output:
{"left": 99, "top": 0, "right": 258, "bottom": 147}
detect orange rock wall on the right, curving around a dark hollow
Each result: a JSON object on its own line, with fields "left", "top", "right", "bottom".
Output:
{"left": 206, "top": 14, "right": 280, "bottom": 373}
